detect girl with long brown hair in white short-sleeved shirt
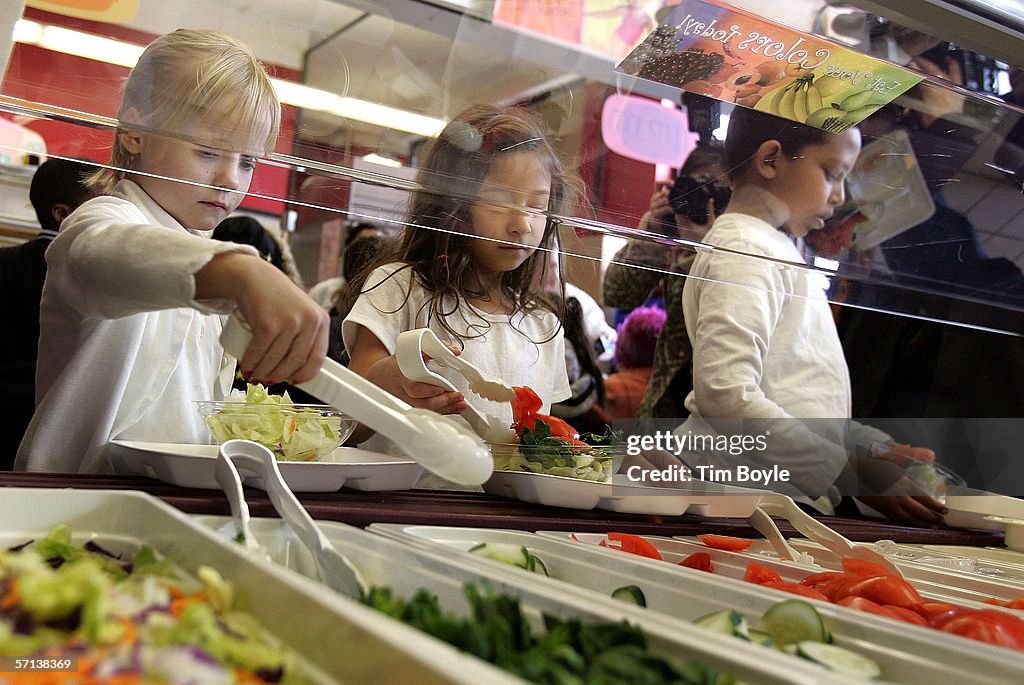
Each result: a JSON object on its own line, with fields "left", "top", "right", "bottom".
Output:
{"left": 341, "top": 104, "right": 569, "bottom": 442}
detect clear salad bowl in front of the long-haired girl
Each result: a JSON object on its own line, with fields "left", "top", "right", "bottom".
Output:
{"left": 486, "top": 442, "right": 626, "bottom": 482}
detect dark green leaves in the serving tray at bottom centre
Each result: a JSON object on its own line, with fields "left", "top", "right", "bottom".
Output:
{"left": 361, "top": 584, "right": 735, "bottom": 685}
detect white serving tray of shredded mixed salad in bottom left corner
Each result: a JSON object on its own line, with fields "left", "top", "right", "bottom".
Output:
{"left": 0, "top": 487, "right": 521, "bottom": 685}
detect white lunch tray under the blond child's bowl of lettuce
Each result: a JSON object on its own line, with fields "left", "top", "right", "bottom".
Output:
{"left": 106, "top": 440, "right": 423, "bottom": 493}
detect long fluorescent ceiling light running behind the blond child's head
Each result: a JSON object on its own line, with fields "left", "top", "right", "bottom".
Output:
{"left": 14, "top": 19, "right": 445, "bottom": 136}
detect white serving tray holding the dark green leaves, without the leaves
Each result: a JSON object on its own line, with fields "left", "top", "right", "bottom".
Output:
{"left": 196, "top": 516, "right": 862, "bottom": 685}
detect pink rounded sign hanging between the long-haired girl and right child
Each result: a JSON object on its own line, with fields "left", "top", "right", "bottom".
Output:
{"left": 601, "top": 93, "right": 700, "bottom": 168}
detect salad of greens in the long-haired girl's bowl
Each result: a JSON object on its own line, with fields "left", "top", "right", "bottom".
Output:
{"left": 495, "top": 419, "right": 624, "bottom": 482}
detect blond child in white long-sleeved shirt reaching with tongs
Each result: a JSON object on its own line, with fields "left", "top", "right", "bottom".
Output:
{"left": 15, "top": 30, "right": 328, "bottom": 472}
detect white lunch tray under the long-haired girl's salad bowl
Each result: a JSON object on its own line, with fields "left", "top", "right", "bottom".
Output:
{"left": 483, "top": 471, "right": 766, "bottom": 518}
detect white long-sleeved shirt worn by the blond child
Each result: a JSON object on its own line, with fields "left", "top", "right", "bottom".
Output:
{"left": 15, "top": 180, "right": 258, "bottom": 473}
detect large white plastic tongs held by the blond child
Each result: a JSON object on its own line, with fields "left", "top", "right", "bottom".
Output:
{"left": 220, "top": 315, "right": 494, "bottom": 485}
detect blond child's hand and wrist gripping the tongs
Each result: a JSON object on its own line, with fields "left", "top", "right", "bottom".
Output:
{"left": 196, "top": 252, "right": 331, "bottom": 385}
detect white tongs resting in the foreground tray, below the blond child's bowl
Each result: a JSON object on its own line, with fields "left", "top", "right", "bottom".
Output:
{"left": 216, "top": 440, "right": 367, "bottom": 597}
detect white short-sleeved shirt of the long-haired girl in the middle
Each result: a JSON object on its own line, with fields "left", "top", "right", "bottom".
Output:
{"left": 342, "top": 262, "right": 571, "bottom": 449}
